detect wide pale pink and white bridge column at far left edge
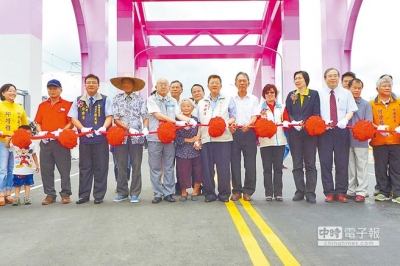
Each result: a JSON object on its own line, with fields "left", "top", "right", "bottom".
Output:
{"left": 0, "top": 0, "right": 43, "bottom": 117}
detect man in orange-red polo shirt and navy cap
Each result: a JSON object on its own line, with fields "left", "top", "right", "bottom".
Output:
{"left": 35, "top": 79, "right": 72, "bottom": 205}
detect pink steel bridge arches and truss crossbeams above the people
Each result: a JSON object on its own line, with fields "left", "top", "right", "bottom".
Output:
{"left": 0, "top": 0, "right": 363, "bottom": 98}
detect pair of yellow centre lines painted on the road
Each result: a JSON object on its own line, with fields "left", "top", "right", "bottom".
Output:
{"left": 226, "top": 199, "right": 300, "bottom": 265}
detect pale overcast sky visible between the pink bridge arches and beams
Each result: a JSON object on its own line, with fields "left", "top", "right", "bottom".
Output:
{"left": 43, "top": 0, "right": 400, "bottom": 102}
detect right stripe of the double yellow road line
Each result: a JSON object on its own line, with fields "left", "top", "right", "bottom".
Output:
{"left": 240, "top": 199, "right": 300, "bottom": 265}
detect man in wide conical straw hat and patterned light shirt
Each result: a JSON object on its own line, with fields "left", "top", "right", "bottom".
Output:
{"left": 110, "top": 74, "right": 149, "bottom": 203}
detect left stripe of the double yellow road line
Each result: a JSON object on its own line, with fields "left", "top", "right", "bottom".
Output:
{"left": 226, "top": 201, "right": 270, "bottom": 266}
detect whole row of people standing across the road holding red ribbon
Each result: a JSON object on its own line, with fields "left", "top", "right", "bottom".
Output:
{"left": 0, "top": 68, "right": 400, "bottom": 206}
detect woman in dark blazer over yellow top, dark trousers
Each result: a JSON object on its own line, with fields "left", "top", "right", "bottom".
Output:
{"left": 284, "top": 71, "right": 320, "bottom": 203}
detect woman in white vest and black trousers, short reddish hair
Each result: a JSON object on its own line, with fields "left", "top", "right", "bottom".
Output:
{"left": 259, "top": 84, "right": 287, "bottom": 201}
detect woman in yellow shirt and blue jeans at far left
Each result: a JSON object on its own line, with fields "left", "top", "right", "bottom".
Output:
{"left": 0, "top": 84, "right": 29, "bottom": 206}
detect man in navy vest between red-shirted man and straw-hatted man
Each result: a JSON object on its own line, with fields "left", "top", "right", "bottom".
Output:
{"left": 68, "top": 74, "right": 112, "bottom": 204}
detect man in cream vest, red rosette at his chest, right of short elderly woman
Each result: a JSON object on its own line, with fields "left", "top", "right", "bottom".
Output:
{"left": 198, "top": 75, "right": 236, "bottom": 202}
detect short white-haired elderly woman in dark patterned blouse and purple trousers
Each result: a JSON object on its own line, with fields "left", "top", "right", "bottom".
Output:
{"left": 175, "top": 99, "right": 203, "bottom": 201}
